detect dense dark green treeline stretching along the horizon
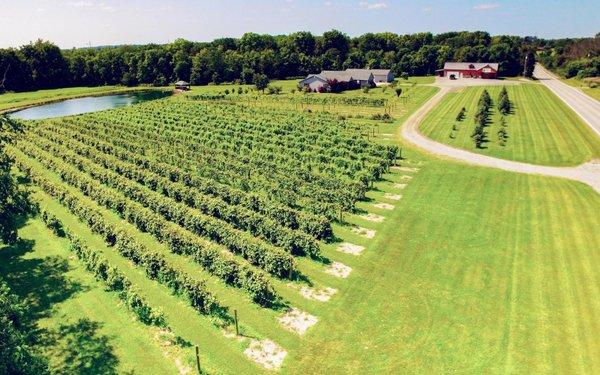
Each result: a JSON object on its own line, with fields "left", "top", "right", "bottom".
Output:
{"left": 0, "top": 30, "right": 592, "bottom": 92}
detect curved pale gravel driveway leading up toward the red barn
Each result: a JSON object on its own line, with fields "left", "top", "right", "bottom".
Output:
{"left": 401, "top": 87, "right": 600, "bottom": 193}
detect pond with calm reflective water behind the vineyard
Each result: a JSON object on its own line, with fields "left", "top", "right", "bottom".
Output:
{"left": 9, "top": 91, "right": 172, "bottom": 120}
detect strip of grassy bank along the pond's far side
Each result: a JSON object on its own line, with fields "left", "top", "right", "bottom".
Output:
{"left": 0, "top": 86, "right": 166, "bottom": 112}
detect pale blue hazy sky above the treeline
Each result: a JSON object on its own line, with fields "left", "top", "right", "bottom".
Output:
{"left": 0, "top": 0, "right": 600, "bottom": 48}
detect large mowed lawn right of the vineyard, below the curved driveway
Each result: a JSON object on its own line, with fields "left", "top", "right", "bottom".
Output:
{"left": 284, "top": 152, "right": 600, "bottom": 374}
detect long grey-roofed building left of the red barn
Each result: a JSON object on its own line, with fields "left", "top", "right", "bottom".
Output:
{"left": 298, "top": 69, "right": 394, "bottom": 91}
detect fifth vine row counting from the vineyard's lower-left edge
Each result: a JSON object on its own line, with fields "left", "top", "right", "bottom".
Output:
{"left": 29, "top": 132, "right": 320, "bottom": 257}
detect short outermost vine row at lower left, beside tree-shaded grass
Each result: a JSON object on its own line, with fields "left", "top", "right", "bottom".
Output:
{"left": 41, "top": 210, "right": 166, "bottom": 327}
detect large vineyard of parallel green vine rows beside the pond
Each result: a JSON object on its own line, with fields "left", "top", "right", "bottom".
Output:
{"left": 7, "top": 98, "right": 408, "bottom": 374}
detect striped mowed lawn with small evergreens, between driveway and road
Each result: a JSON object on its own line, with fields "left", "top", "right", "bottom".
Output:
{"left": 420, "top": 84, "right": 600, "bottom": 166}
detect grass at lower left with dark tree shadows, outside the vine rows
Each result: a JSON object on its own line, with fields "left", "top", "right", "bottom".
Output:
{"left": 0, "top": 219, "right": 177, "bottom": 374}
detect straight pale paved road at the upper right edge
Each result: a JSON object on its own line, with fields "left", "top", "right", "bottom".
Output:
{"left": 533, "top": 64, "right": 600, "bottom": 136}
